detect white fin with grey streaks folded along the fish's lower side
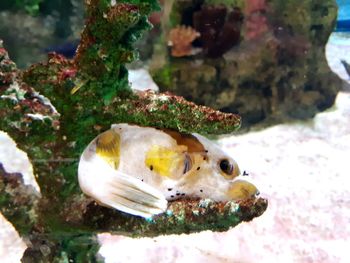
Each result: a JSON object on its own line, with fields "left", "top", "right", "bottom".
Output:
{"left": 103, "top": 171, "right": 168, "bottom": 218}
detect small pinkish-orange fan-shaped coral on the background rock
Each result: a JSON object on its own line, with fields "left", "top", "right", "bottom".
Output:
{"left": 168, "top": 25, "right": 200, "bottom": 57}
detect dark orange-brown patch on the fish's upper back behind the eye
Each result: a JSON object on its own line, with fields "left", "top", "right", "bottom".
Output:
{"left": 162, "top": 129, "right": 205, "bottom": 153}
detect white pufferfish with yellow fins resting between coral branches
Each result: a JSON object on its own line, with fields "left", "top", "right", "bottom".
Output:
{"left": 78, "top": 123, "right": 259, "bottom": 218}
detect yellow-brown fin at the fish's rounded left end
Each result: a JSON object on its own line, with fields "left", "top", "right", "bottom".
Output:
{"left": 96, "top": 130, "right": 120, "bottom": 169}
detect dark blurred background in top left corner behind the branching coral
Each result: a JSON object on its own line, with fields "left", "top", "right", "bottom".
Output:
{"left": 0, "top": 0, "right": 84, "bottom": 68}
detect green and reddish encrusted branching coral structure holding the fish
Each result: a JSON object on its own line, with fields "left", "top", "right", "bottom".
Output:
{"left": 0, "top": 0, "right": 267, "bottom": 262}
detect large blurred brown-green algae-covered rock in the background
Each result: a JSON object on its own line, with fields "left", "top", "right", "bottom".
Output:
{"left": 152, "top": 0, "right": 341, "bottom": 129}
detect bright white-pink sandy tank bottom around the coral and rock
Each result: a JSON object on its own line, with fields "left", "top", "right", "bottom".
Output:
{"left": 0, "top": 34, "right": 350, "bottom": 263}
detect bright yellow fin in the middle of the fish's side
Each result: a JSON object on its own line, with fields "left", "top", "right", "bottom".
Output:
{"left": 145, "top": 145, "right": 187, "bottom": 177}
